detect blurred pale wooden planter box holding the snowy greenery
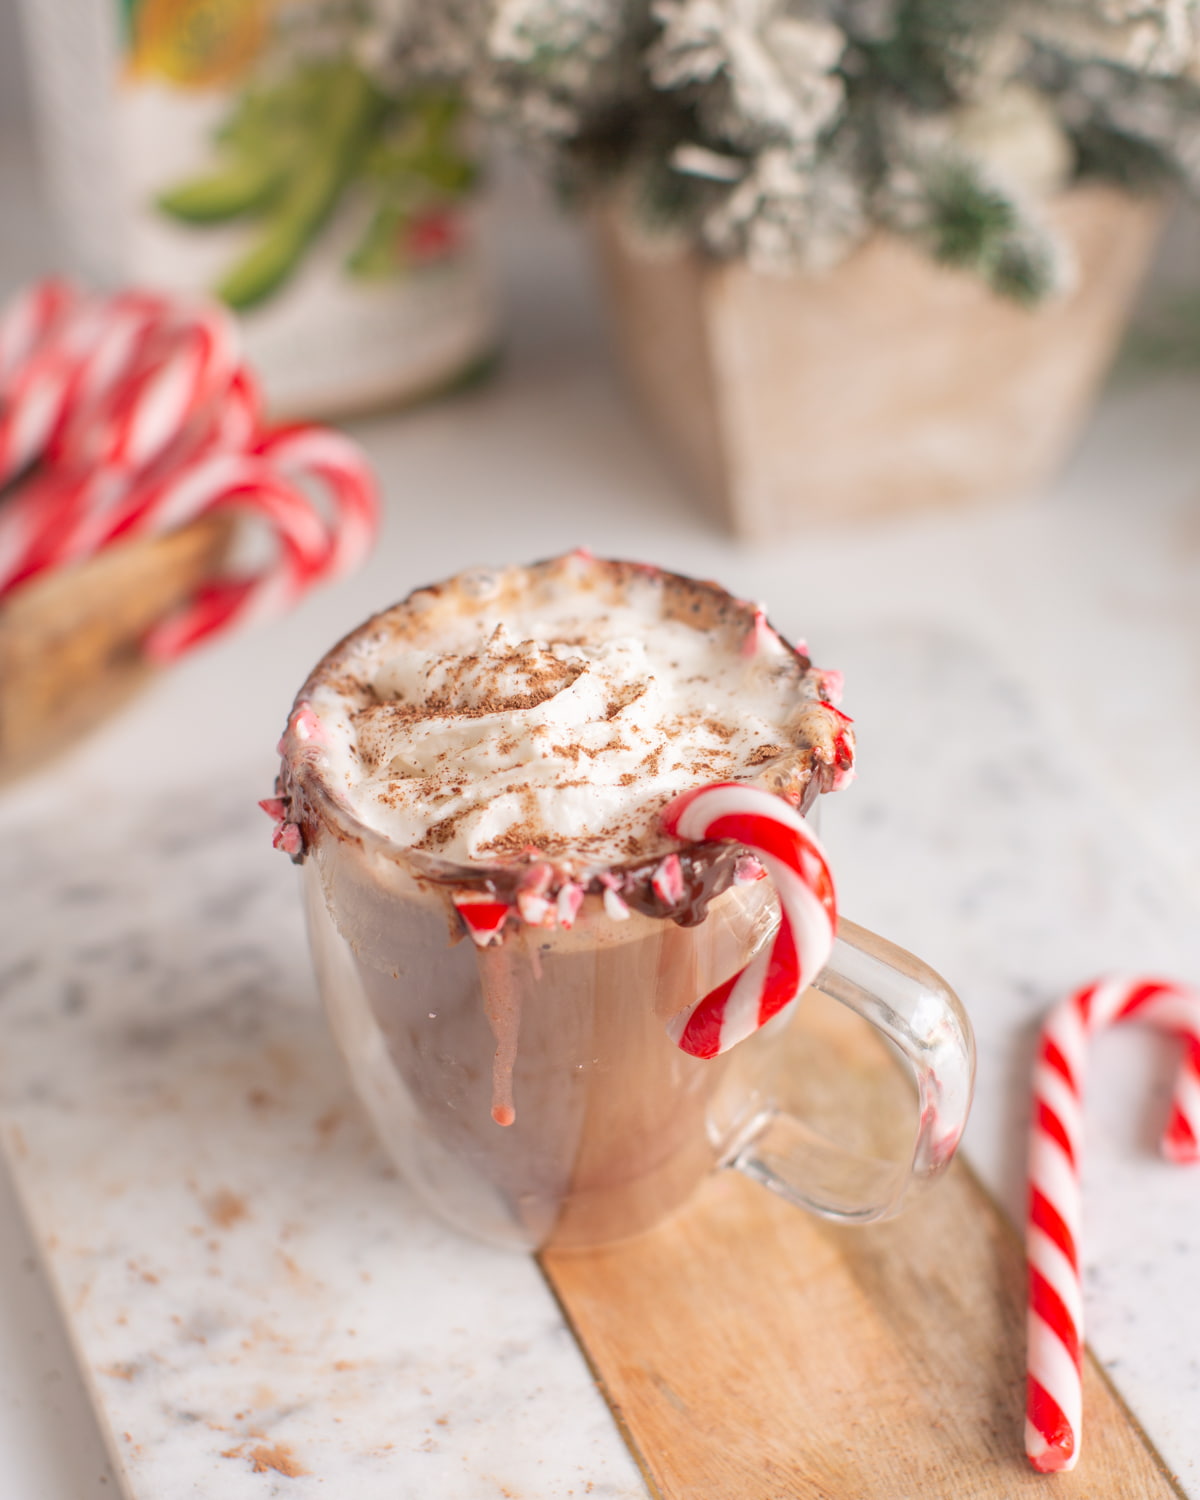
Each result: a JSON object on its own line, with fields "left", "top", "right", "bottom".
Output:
{"left": 597, "top": 185, "right": 1164, "bottom": 539}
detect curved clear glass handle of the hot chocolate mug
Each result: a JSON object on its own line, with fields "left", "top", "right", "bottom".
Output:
{"left": 722, "top": 918, "right": 975, "bottom": 1224}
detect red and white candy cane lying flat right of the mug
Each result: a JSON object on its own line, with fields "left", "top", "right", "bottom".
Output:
{"left": 1025, "top": 980, "right": 1200, "bottom": 1473}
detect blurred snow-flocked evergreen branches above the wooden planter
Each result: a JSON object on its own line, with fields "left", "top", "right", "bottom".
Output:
{"left": 378, "top": 0, "right": 1200, "bottom": 303}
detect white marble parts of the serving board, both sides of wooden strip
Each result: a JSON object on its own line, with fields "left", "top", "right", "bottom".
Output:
{"left": 0, "top": 629, "right": 1200, "bottom": 1500}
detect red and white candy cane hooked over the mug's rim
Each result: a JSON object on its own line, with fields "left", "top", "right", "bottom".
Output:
{"left": 663, "top": 782, "right": 837, "bottom": 1058}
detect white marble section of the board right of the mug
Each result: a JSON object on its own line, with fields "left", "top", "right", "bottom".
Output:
{"left": 822, "top": 627, "right": 1200, "bottom": 1497}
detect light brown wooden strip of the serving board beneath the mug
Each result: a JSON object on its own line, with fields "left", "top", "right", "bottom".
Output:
{"left": 542, "top": 993, "right": 1182, "bottom": 1500}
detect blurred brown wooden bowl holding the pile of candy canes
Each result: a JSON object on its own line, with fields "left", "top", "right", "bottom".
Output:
{"left": 0, "top": 516, "right": 233, "bottom": 780}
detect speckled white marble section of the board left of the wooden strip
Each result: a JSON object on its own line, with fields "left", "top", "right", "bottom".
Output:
{"left": 0, "top": 779, "right": 645, "bottom": 1500}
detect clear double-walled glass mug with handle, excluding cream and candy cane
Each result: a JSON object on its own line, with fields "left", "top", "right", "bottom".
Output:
{"left": 276, "top": 558, "right": 974, "bottom": 1248}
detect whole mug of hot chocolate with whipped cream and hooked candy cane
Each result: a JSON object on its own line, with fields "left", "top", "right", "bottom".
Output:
{"left": 264, "top": 552, "right": 974, "bottom": 1248}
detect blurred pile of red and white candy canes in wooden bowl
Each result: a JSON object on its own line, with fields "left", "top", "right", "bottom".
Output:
{"left": 0, "top": 281, "right": 378, "bottom": 662}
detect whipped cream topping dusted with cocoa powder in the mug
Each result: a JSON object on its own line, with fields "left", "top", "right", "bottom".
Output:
{"left": 284, "top": 552, "right": 854, "bottom": 873}
